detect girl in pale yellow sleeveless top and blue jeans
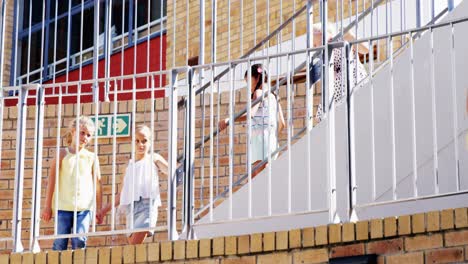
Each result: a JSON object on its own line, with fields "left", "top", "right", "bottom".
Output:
{"left": 41, "top": 116, "right": 102, "bottom": 250}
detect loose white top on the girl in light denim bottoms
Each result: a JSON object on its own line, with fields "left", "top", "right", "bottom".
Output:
{"left": 120, "top": 155, "right": 161, "bottom": 206}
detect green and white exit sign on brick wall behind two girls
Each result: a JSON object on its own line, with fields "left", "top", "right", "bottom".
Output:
{"left": 91, "top": 114, "right": 132, "bottom": 138}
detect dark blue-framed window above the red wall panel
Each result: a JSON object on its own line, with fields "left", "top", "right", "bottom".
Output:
{"left": 16, "top": 0, "right": 166, "bottom": 83}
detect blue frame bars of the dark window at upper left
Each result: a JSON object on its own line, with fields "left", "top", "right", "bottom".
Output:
{"left": 10, "top": 0, "right": 167, "bottom": 85}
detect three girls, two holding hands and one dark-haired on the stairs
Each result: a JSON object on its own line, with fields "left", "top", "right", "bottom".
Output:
{"left": 41, "top": 64, "right": 285, "bottom": 250}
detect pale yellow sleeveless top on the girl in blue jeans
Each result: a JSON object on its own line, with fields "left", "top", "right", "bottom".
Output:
{"left": 53, "top": 148, "right": 99, "bottom": 211}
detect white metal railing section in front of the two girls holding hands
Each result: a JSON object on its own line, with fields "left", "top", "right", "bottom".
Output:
{"left": 1, "top": 68, "right": 188, "bottom": 251}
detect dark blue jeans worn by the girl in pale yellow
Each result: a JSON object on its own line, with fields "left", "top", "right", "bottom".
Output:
{"left": 52, "top": 210, "right": 91, "bottom": 250}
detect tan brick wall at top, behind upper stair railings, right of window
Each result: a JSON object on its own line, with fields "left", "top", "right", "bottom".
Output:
{"left": 166, "top": 0, "right": 380, "bottom": 68}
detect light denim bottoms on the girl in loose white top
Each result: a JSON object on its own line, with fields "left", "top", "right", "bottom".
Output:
{"left": 126, "top": 198, "right": 158, "bottom": 236}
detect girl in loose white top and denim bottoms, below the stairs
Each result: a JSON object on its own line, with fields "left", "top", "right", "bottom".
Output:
{"left": 100, "top": 125, "right": 168, "bottom": 244}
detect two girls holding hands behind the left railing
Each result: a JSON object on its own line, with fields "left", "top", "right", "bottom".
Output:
{"left": 41, "top": 116, "right": 168, "bottom": 250}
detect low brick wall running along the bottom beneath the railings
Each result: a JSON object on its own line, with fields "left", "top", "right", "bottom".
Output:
{"left": 4, "top": 208, "right": 468, "bottom": 264}
